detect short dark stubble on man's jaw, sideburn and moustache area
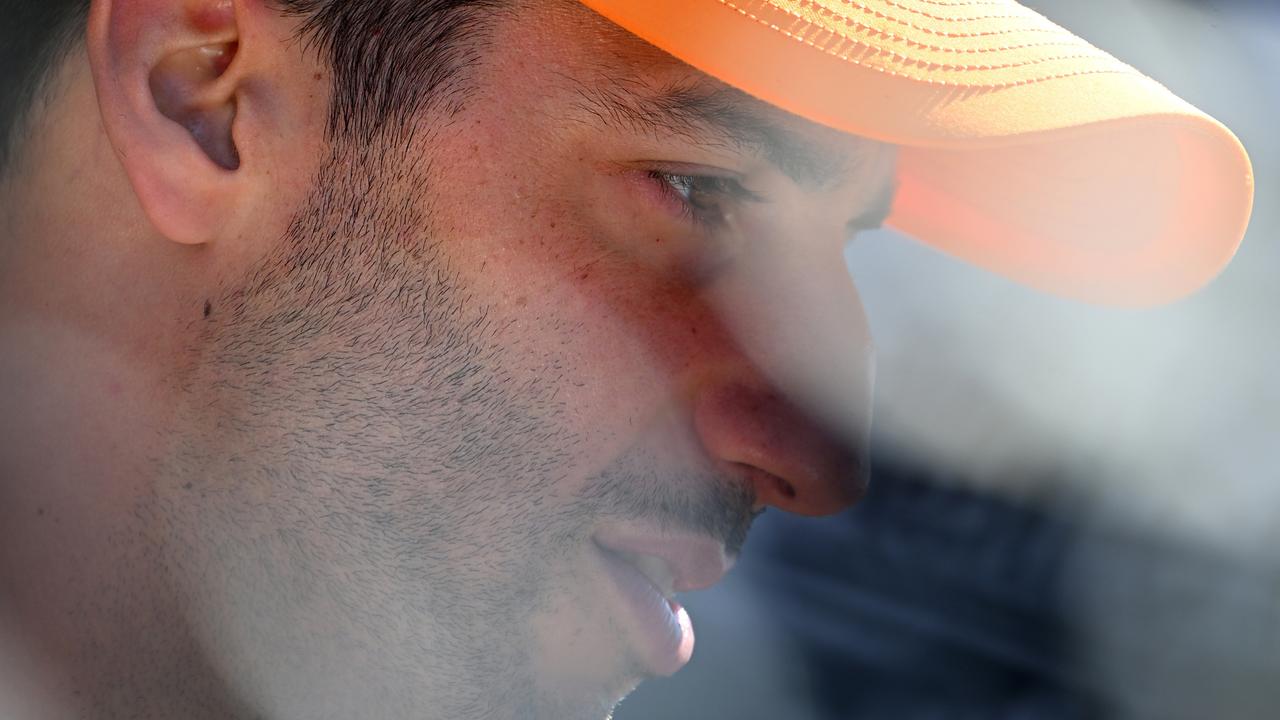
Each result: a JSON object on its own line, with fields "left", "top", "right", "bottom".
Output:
{"left": 154, "top": 126, "right": 754, "bottom": 720}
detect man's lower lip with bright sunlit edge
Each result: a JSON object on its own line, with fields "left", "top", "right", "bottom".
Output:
{"left": 600, "top": 548, "right": 694, "bottom": 676}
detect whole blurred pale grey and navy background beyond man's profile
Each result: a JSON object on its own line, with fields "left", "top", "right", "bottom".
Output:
{"left": 616, "top": 0, "right": 1280, "bottom": 720}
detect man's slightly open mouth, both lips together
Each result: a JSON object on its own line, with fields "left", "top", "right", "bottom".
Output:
{"left": 593, "top": 528, "right": 732, "bottom": 676}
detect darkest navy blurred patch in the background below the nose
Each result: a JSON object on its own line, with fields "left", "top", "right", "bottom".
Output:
{"left": 751, "top": 465, "right": 1100, "bottom": 719}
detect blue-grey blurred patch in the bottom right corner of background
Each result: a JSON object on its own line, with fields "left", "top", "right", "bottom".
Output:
{"left": 1064, "top": 509, "right": 1280, "bottom": 720}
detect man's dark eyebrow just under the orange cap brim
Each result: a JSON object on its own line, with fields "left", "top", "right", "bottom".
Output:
{"left": 579, "top": 78, "right": 893, "bottom": 190}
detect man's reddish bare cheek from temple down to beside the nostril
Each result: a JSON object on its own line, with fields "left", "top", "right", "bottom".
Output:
{"left": 409, "top": 116, "right": 728, "bottom": 454}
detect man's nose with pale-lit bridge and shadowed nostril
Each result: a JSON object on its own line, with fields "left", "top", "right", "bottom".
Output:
{"left": 694, "top": 242, "right": 873, "bottom": 515}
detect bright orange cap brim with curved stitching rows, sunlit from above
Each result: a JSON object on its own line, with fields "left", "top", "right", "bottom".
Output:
{"left": 581, "top": 0, "right": 1253, "bottom": 305}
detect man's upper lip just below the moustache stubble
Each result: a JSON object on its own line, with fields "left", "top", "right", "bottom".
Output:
{"left": 593, "top": 527, "right": 733, "bottom": 594}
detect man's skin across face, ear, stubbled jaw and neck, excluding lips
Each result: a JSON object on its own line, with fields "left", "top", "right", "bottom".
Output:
{"left": 0, "top": 0, "right": 893, "bottom": 719}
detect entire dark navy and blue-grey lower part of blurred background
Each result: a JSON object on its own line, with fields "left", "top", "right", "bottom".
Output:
{"left": 617, "top": 452, "right": 1280, "bottom": 720}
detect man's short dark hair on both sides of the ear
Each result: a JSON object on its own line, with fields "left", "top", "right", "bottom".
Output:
{"left": 0, "top": 0, "right": 509, "bottom": 170}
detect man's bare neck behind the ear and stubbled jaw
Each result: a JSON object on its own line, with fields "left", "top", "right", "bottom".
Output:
{"left": 0, "top": 58, "right": 242, "bottom": 720}
